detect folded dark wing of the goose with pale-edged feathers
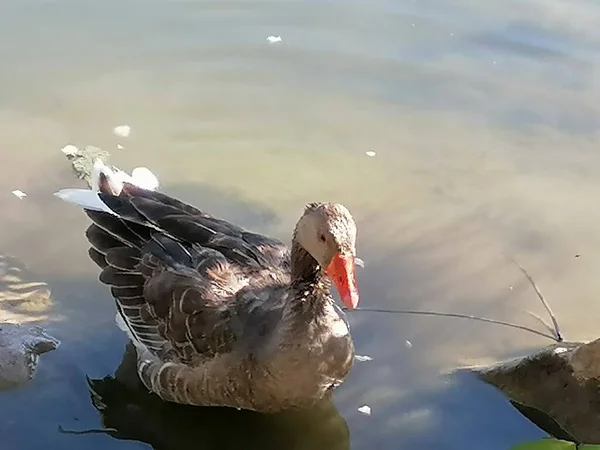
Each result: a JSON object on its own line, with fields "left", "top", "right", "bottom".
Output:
{"left": 77, "top": 183, "right": 289, "bottom": 364}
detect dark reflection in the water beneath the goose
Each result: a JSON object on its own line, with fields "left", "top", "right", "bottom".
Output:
{"left": 74, "top": 344, "right": 350, "bottom": 450}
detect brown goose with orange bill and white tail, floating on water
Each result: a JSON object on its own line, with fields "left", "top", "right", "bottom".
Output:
{"left": 55, "top": 163, "right": 359, "bottom": 413}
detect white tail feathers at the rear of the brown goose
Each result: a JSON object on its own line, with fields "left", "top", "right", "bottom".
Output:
{"left": 54, "top": 159, "right": 159, "bottom": 214}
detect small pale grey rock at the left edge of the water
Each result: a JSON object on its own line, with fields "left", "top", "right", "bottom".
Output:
{"left": 0, "top": 323, "right": 60, "bottom": 390}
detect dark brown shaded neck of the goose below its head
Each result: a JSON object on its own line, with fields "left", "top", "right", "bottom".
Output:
{"left": 288, "top": 239, "right": 331, "bottom": 321}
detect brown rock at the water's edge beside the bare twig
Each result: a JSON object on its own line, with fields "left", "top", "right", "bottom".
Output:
{"left": 471, "top": 339, "right": 600, "bottom": 444}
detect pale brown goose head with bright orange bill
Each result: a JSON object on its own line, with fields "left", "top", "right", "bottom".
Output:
{"left": 296, "top": 203, "right": 359, "bottom": 309}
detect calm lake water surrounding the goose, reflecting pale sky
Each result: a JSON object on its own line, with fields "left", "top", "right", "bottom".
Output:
{"left": 0, "top": 0, "right": 600, "bottom": 450}
